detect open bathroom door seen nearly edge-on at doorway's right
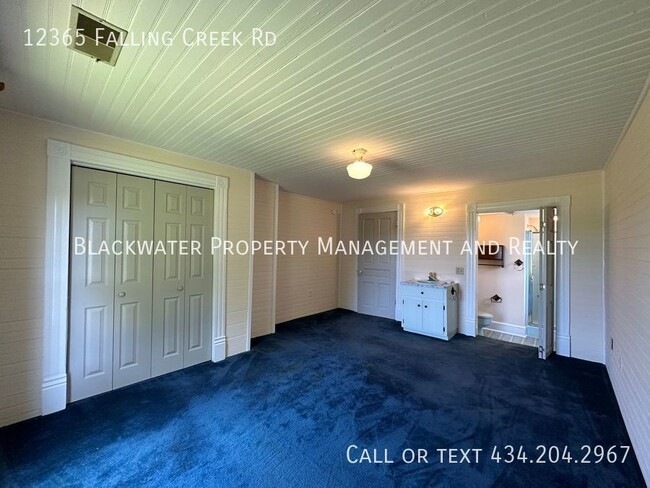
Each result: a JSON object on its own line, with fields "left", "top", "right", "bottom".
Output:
{"left": 538, "top": 207, "right": 555, "bottom": 359}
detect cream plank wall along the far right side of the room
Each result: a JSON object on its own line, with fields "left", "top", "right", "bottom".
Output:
{"left": 605, "top": 86, "right": 650, "bottom": 484}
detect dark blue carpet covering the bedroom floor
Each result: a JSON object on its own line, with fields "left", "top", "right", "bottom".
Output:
{"left": 0, "top": 310, "right": 645, "bottom": 488}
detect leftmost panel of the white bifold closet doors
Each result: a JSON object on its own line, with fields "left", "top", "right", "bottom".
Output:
{"left": 69, "top": 166, "right": 117, "bottom": 401}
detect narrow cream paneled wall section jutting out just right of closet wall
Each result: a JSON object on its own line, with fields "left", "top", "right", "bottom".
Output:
{"left": 251, "top": 180, "right": 278, "bottom": 337}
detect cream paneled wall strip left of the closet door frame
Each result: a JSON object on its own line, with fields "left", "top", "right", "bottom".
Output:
{"left": 0, "top": 117, "right": 46, "bottom": 425}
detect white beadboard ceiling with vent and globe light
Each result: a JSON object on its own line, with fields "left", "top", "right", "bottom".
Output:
{"left": 0, "top": 0, "right": 650, "bottom": 201}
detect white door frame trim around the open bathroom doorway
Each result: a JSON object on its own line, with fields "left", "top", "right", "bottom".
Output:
{"left": 461, "top": 196, "right": 571, "bottom": 357}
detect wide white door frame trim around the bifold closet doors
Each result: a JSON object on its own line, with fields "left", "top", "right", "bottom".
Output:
{"left": 41, "top": 139, "right": 229, "bottom": 415}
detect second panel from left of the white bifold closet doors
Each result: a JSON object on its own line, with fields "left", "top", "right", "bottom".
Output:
{"left": 113, "top": 175, "right": 154, "bottom": 388}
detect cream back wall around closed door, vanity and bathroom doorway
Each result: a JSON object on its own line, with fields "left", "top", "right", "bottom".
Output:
{"left": 339, "top": 171, "right": 604, "bottom": 362}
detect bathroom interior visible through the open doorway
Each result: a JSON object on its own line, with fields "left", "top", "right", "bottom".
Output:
{"left": 476, "top": 210, "right": 540, "bottom": 347}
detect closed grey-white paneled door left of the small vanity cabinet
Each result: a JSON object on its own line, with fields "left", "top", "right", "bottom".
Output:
{"left": 357, "top": 212, "right": 397, "bottom": 319}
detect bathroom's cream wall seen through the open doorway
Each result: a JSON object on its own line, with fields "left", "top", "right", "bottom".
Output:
{"left": 476, "top": 214, "right": 526, "bottom": 326}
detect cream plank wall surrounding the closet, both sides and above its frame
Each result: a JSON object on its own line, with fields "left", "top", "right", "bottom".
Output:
{"left": 0, "top": 110, "right": 252, "bottom": 426}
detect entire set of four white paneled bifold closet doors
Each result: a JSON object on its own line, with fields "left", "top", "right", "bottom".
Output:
{"left": 69, "top": 170, "right": 214, "bottom": 401}
